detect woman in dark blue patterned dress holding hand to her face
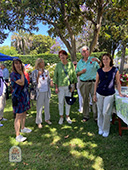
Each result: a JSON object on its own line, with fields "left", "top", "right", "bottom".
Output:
{"left": 10, "top": 58, "right": 31, "bottom": 142}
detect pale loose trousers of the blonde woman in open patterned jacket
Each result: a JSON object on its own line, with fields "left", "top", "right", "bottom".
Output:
{"left": 36, "top": 92, "right": 50, "bottom": 124}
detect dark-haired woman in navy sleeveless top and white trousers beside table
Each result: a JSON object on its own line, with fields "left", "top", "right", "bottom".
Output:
{"left": 93, "top": 53, "right": 123, "bottom": 137}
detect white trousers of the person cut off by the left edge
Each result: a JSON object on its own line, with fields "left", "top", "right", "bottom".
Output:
{"left": 0, "top": 93, "right": 6, "bottom": 118}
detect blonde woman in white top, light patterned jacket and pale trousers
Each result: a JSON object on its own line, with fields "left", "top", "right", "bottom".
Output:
{"left": 34, "top": 58, "right": 52, "bottom": 128}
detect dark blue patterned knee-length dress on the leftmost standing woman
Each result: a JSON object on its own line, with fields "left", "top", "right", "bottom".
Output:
{"left": 10, "top": 72, "right": 30, "bottom": 113}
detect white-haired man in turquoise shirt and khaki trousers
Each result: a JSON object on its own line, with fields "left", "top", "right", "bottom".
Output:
{"left": 76, "top": 46, "right": 100, "bottom": 122}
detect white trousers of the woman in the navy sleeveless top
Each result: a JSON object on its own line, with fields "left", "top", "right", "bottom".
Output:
{"left": 97, "top": 93, "right": 114, "bottom": 133}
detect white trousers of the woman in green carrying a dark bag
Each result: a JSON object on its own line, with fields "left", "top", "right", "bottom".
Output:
{"left": 58, "top": 86, "right": 71, "bottom": 116}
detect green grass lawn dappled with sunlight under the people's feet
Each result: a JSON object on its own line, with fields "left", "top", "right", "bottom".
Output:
{"left": 0, "top": 89, "right": 128, "bottom": 170}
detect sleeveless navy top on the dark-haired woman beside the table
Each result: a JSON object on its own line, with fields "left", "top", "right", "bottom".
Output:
{"left": 97, "top": 67, "right": 118, "bottom": 96}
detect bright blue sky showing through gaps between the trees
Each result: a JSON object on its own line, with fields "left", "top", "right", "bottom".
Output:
{"left": 0, "top": 23, "right": 48, "bottom": 47}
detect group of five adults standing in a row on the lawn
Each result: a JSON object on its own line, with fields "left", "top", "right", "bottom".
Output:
{"left": 0, "top": 46, "right": 123, "bottom": 142}
